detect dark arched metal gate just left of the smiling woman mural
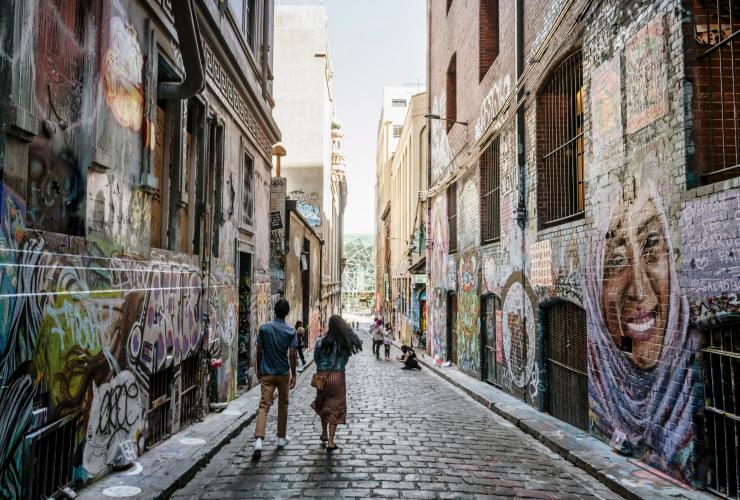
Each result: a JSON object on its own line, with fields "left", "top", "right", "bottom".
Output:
{"left": 545, "top": 302, "right": 588, "bottom": 430}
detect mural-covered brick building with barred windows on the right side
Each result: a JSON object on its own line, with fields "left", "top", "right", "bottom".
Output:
{"left": 426, "top": 0, "right": 740, "bottom": 496}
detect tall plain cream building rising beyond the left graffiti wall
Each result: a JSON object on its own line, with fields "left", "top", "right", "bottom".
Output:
{"left": 273, "top": 4, "right": 347, "bottom": 332}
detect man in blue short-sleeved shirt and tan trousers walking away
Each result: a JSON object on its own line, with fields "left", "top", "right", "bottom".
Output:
{"left": 252, "top": 298, "right": 298, "bottom": 460}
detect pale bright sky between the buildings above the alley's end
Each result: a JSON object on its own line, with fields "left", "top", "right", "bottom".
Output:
{"left": 324, "top": 0, "right": 426, "bottom": 234}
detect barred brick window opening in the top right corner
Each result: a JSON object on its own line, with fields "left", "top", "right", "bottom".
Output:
{"left": 692, "top": 0, "right": 740, "bottom": 184}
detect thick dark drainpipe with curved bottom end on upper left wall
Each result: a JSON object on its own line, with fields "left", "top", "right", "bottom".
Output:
{"left": 157, "top": 0, "right": 206, "bottom": 101}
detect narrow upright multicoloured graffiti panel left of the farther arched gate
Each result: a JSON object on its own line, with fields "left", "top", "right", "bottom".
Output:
{"left": 456, "top": 253, "right": 480, "bottom": 376}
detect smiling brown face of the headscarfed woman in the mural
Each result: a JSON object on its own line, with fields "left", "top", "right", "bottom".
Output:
{"left": 602, "top": 197, "right": 670, "bottom": 370}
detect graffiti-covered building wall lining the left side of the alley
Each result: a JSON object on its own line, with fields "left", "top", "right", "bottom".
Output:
{"left": 0, "top": 1, "right": 279, "bottom": 498}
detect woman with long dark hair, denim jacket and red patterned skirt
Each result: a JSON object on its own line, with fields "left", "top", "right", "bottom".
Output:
{"left": 311, "top": 315, "right": 362, "bottom": 451}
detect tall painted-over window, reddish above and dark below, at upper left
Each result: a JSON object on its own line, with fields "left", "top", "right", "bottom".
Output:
{"left": 26, "top": 0, "right": 87, "bottom": 236}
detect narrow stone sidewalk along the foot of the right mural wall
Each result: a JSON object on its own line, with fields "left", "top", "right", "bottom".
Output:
{"left": 376, "top": 332, "right": 704, "bottom": 500}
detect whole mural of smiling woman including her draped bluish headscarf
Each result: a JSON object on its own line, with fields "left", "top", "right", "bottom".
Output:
{"left": 586, "top": 184, "right": 701, "bottom": 480}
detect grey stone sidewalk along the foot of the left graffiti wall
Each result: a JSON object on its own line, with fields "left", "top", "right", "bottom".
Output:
{"left": 77, "top": 353, "right": 313, "bottom": 500}
